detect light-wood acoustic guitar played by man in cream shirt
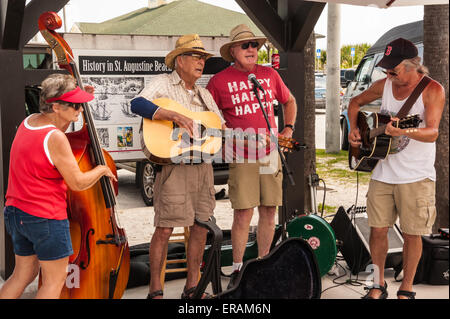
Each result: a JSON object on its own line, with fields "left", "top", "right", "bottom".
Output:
{"left": 141, "top": 98, "right": 301, "bottom": 165}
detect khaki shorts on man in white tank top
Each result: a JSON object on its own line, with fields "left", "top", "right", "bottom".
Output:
{"left": 367, "top": 178, "right": 436, "bottom": 235}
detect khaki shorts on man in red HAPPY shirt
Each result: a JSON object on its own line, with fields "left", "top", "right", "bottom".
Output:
{"left": 228, "top": 152, "right": 283, "bottom": 209}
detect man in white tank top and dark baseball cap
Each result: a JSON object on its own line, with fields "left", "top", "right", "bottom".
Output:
{"left": 348, "top": 38, "right": 445, "bottom": 299}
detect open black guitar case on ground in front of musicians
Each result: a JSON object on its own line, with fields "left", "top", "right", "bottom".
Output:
{"left": 216, "top": 238, "right": 322, "bottom": 299}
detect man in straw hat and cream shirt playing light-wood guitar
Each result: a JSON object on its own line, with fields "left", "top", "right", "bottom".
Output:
{"left": 131, "top": 34, "right": 224, "bottom": 299}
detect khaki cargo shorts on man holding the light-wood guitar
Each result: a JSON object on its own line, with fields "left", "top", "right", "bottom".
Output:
{"left": 153, "top": 163, "right": 216, "bottom": 227}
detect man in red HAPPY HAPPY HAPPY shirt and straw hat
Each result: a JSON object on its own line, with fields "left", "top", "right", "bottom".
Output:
{"left": 207, "top": 24, "right": 297, "bottom": 288}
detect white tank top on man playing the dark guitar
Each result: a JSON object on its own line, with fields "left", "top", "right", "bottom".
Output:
{"left": 372, "top": 79, "right": 436, "bottom": 184}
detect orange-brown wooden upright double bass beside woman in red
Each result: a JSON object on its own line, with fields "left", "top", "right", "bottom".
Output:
{"left": 39, "top": 12, "right": 130, "bottom": 299}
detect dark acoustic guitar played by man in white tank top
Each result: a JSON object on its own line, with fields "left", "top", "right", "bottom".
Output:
{"left": 348, "top": 112, "right": 422, "bottom": 172}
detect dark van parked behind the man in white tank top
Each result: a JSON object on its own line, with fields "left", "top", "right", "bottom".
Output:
{"left": 340, "top": 20, "right": 423, "bottom": 150}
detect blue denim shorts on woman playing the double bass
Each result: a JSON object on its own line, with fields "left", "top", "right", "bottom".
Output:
{"left": 3, "top": 206, "right": 73, "bottom": 260}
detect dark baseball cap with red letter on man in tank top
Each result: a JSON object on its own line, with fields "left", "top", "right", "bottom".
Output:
{"left": 376, "top": 38, "right": 419, "bottom": 69}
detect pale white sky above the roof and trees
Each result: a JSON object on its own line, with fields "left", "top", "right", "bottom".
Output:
{"left": 43, "top": 0, "right": 423, "bottom": 50}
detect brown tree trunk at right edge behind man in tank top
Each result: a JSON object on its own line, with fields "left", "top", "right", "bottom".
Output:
{"left": 423, "top": 4, "right": 449, "bottom": 232}
